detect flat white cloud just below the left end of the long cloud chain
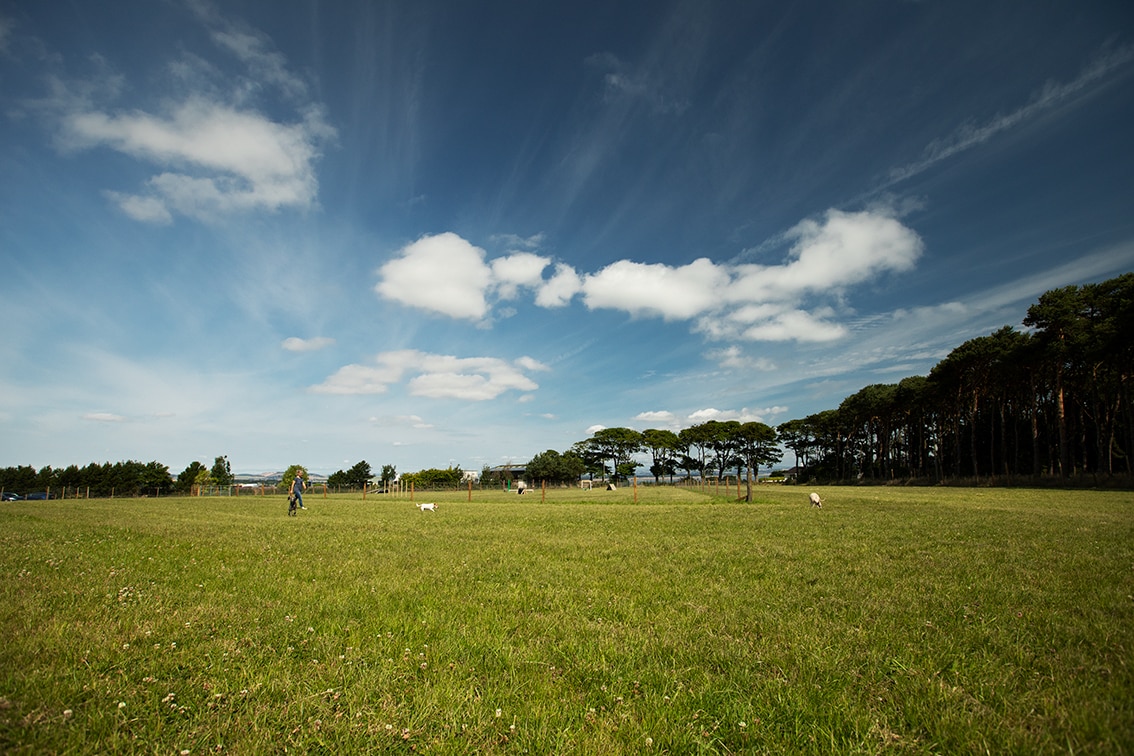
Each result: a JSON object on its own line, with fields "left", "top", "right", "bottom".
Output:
{"left": 311, "top": 349, "right": 548, "bottom": 401}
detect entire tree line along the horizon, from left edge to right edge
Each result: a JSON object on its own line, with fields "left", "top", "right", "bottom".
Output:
{"left": 0, "top": 273, "right": 1134, "bottom": 496}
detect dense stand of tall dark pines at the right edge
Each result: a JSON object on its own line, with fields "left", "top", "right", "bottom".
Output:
{"left": 778, "top": 273, "right": 1134, "bottom": 483}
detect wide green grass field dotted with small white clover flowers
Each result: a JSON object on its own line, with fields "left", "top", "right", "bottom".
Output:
{"left": 0, "top": 486, "right": 1134, "bottom": 754}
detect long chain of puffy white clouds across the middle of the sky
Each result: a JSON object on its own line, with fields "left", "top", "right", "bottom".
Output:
{"left": 375, "top": 210, "right": 924, "bottom": 342}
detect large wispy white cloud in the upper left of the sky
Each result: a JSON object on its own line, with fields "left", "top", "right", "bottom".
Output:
{"left": 36, "top": 2, "right": 336, "bottom": 223}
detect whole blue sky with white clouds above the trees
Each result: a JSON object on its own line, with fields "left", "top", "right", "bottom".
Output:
{"left": 0, "top": 0, "right": 1134, "bottom": 476}
